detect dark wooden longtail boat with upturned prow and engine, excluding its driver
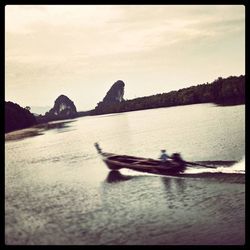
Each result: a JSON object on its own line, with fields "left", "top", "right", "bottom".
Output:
{"left": 95, "top": 143, "right": 186, "bottom": 175}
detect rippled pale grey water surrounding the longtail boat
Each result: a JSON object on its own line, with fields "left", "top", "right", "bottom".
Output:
{"left": 5, "top": 104, "right": 245, "bottom": 245}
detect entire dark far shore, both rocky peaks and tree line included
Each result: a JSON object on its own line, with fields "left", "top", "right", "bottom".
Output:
{"left": 5, "top": 75, "right": 245, "bottom": 133}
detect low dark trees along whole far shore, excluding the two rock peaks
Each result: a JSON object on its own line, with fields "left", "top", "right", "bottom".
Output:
{"left": 5, "top": 75, "right": 245, "bottom": 133}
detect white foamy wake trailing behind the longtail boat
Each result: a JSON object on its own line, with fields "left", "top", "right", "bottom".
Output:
{"left": 184, "top": 156, "right": 245, "bottom": 174}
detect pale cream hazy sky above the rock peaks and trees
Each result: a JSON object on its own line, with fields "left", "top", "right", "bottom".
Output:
{"left": 5, "top": 5, "right": 245, "bottom": 111}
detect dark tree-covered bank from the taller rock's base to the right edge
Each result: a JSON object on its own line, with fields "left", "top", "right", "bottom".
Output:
{"left": 91, "top": 75, "right": 245, "bottom": 115}
